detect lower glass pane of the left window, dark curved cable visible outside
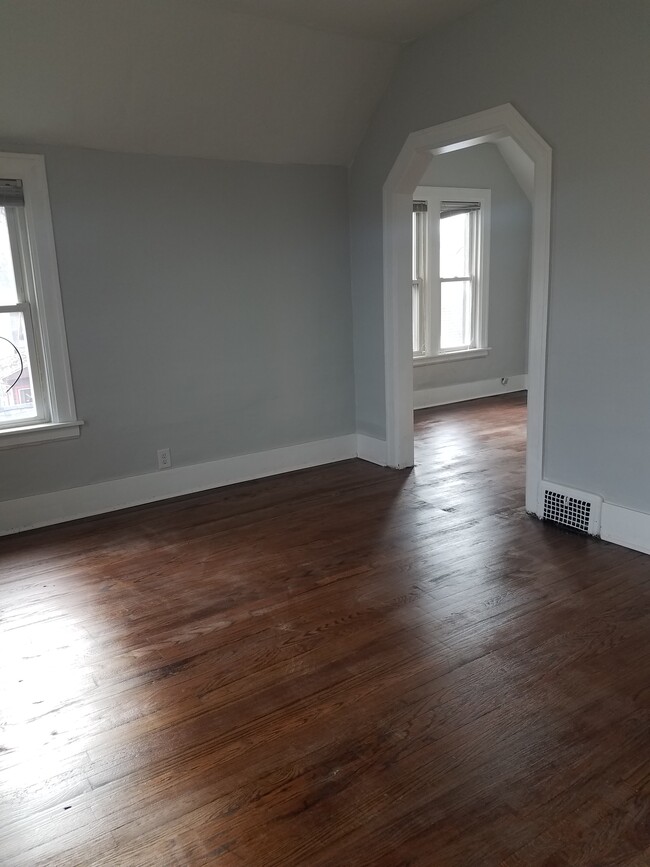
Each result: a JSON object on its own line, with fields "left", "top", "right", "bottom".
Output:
{"left": 0, "top": 312, "right": 36, "bottom": 425}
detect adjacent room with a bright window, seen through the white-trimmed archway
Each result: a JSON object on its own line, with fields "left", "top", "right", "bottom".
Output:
{"left": 411, "top": 137, "right": 535, "bottom": 514}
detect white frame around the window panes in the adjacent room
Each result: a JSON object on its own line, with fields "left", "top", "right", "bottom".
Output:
{"left": 413, "top": 186, "right": 492, "bottom": 366}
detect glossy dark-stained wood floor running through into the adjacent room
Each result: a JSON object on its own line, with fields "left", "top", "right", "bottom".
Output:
{"left": 0, "top": 396, "right": 650, "bottom": 867}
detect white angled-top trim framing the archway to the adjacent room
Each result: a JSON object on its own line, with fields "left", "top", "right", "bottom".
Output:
{"left": 384, "top": 104, "right": 551, "bottom": 514}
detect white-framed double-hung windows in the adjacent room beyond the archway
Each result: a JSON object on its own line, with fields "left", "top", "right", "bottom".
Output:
{"left": 412, "top": 187, "right": 490, "bottom": 363}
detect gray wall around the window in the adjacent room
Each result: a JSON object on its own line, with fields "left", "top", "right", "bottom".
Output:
{"left": 413, "top": 144, "right": 531, "bottom": 389}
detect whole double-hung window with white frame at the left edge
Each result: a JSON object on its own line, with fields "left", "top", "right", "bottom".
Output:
{"left": 0, "top": 154, "right": 81, "bottom": 448}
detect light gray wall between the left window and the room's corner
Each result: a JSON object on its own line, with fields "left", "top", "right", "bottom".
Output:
{"left": 0, "top": 143, "right": 354, "bottom": 500}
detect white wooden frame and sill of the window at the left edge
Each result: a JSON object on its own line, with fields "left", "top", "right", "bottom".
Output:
{"left": 0, "top": 153, "right": 83, "bottom": 448}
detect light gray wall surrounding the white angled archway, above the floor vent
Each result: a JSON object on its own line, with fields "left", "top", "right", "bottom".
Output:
{"left": 351, "top": 0, "right": 650, "bottom": 512}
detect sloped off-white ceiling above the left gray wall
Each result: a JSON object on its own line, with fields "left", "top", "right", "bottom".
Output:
{"left": 0, "top": 0, "right": 492, "bottom": 165}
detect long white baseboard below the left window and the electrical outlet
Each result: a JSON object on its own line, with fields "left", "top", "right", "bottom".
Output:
{"left": 0, "top": 434, "right": 358, "bottom": 536}
